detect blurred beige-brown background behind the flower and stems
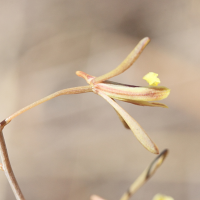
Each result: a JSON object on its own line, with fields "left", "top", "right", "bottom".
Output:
{"left": 0, "top": 0, "right": 200, "bottom": 200}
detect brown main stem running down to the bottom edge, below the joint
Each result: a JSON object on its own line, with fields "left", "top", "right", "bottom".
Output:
{"left": 0, "top": 125, "right": 25, "bottom": 200}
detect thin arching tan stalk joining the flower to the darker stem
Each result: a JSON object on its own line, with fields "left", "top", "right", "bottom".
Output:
{"left": 3, "top": 85, "right": 92, "bottom": 124}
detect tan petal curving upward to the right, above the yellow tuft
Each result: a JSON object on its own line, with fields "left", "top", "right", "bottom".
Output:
{"left": 93, "top": 37, "right": 150, "bottom": 83}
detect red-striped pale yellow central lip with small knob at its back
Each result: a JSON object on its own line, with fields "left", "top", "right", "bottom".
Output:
{"left": 76, "top": 71, "right": 170, "bottom": 103}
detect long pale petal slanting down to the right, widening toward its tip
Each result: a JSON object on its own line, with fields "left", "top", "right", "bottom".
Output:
{"left": 98, "top": 91, "right": 159, "bottom": 154}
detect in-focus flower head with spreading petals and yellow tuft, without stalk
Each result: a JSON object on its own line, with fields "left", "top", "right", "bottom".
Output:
{"left": 76, "top": 38, "right": 170, "bottom": 154}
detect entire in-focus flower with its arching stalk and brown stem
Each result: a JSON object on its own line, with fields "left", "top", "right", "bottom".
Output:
{"left": 0, "top": 37, "right": 170, "bottom": 200}
